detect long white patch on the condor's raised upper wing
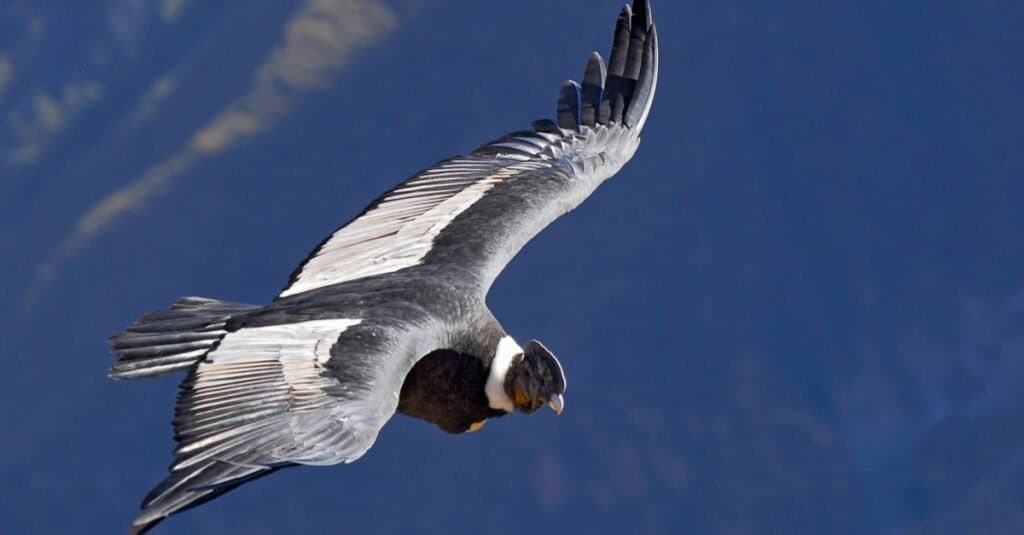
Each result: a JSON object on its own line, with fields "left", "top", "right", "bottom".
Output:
{"left": 281, "top": 158, "right": 551, "bottom": 297}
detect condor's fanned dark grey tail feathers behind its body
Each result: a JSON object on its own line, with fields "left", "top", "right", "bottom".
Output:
{"left": 108, "top": 297, "right": 258, "bottom": 379}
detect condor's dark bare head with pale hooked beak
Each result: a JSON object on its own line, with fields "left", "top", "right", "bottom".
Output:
{"left": 504, "top": 340, "right": 565, "bottom": 414}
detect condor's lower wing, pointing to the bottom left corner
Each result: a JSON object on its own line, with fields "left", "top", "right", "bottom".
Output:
{"left": 133, "top": 318, "right": 422, "bottom": 533}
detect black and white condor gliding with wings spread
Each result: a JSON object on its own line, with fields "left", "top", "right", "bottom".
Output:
{"left": 108, "top": 0, "right": 658, "bottom": 534}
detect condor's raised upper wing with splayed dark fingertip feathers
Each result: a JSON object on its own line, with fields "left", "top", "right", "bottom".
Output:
{"left": 279, "top": 0, "right": 658, "bottom": 297}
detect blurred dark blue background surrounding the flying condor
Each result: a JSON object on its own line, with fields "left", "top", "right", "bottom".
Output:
{"left": 0, "top": 0, "right": 1024, "bottom": 533}
